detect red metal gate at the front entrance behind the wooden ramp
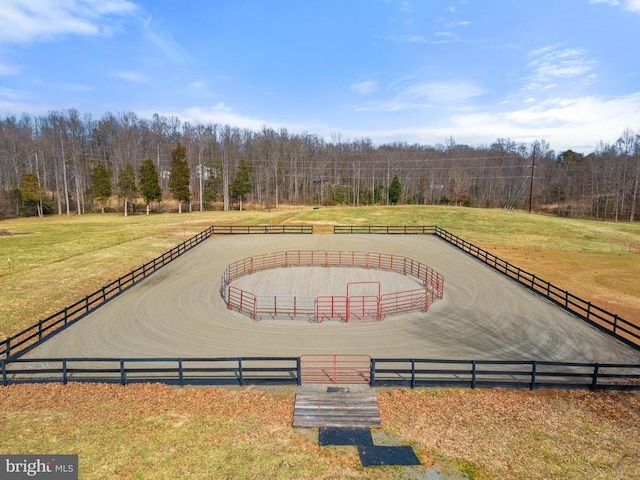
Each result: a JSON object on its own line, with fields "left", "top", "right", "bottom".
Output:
{"left": 300, "top": 354, "right": 371, "bottom": 384}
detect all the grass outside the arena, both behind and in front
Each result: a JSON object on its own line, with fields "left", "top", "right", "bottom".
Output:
{"left": 0, "top": 206, "right": 640, "bottom": 479}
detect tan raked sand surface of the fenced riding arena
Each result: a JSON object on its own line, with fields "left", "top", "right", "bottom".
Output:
{"left": 27, "top": 235, "right": 640, "bottom": 363}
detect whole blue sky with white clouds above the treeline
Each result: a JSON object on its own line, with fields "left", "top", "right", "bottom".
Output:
{"left": 0, "top": 0, "right": 640, "bottom": 153}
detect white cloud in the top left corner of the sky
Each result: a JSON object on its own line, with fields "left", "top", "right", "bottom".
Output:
{"left": 0, "top": 0, "right": 136, "bottom": 43}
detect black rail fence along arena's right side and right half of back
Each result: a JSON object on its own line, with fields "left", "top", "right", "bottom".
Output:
{"left": 333, "top": 225, "right": 640, "bottom": 349}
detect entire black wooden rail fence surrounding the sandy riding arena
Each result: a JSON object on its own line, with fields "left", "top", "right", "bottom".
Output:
{"left": 0, "top": 225, "right": 640, "bottom": 391}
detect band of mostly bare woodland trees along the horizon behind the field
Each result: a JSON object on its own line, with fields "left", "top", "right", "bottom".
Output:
{"left": 0, "top": 109, "right": 640, "bottom": 220}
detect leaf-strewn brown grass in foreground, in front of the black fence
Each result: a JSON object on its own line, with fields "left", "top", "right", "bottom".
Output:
{"left": 0, "top": 384, "right": 640, "bottom": 480}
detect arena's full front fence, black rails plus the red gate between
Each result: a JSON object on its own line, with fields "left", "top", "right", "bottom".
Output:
{"left": 0, "top": 355, "right": 640, "bottom": 391}
